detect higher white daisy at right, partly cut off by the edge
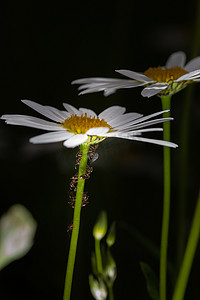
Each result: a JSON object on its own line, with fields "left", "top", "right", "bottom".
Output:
{"left": 72, "top": 51, "right": 200, "bottom": 97}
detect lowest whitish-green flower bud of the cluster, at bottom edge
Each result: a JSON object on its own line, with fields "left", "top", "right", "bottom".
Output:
{"left": 89, "top": 274, "right": 108, "bottom": 300}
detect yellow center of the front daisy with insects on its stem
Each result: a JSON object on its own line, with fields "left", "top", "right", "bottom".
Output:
{"left": 61, "top": 113, "right": 111, "bottom": 134}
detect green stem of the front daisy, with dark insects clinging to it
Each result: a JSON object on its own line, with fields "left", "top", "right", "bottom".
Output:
{"left": 63, "top": 144, "right": 89, "bottom": 300}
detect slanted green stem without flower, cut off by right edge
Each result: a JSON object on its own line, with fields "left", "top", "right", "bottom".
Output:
{"left": 172, "top": 191, "right": 200, "bottom": 300}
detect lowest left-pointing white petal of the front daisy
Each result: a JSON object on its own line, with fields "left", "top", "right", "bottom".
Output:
{"left": 29, "top": 131, "right": 74, "bottom": 144}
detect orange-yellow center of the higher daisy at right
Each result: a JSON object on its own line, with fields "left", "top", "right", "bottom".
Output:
{"left": 144, "top": 67, "right": 188, "bottom": 82}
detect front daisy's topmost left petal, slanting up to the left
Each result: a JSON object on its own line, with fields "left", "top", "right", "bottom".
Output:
{"left": 21, "top": 100, "right": 63, "bottom": 123}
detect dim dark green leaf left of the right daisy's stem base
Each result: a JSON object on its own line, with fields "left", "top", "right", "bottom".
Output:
{"left": 140, "top": 262, "right": 159, "bottom": 300}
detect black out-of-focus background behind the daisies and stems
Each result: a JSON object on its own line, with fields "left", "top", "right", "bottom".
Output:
{"left": 0, "top": 0, "right": 200, "bottom": 300}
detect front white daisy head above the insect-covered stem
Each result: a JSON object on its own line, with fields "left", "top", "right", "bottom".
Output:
{"left": 1, "top": 100, "right": 177, "bottom": 148}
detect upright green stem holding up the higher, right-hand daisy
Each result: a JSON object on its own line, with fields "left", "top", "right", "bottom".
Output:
{"left": 160, "top": 96, "right": 171, "bottom": 300}
